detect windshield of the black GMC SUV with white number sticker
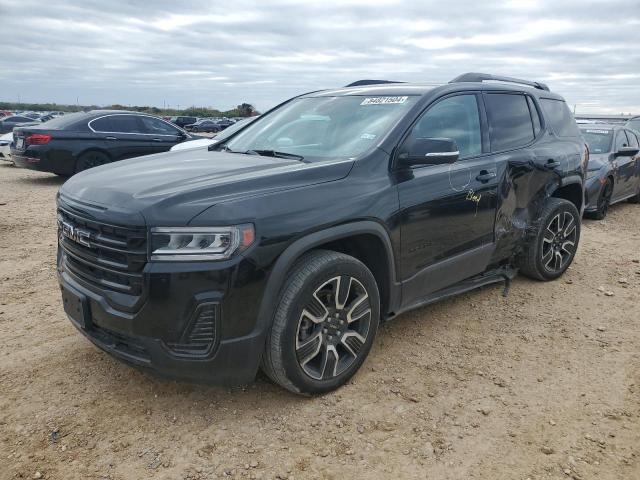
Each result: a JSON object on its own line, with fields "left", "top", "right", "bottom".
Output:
{"left": 221, "top": 96, "right": 418, "bottom": 161}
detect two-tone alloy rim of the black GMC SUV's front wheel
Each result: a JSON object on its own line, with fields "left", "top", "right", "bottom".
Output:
{"left": 296, "top": 275, "right": 371, "bottom": 380}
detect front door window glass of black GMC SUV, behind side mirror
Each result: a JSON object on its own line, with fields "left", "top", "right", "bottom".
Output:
{"left": 411, "top": 95, "right": 482, "bottom": 159}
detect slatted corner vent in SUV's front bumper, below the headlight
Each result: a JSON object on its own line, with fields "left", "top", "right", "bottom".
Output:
{"left": 167, "top": 302, "right": 218, "bottom": 357}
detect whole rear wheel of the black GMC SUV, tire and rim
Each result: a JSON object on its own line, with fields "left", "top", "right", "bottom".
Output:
{"left": 519, "top": 198, "right": 580, "bottom": 281}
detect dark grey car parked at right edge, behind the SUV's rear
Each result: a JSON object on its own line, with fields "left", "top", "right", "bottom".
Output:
{"left": 580, "top": 123, "right": 640, "bottom": 220}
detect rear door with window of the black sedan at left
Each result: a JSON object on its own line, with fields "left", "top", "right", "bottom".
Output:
{"left": 89, "top": 114, "right": 153, "bottom": 160}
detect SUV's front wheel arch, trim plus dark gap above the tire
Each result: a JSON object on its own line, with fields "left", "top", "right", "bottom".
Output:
{"left": 258, "top": 220, "right": 400, "bottom": 331}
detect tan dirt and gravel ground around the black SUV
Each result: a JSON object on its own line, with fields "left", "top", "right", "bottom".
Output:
{"left": 0, "top": 165, "right": 640, "bottom": 480}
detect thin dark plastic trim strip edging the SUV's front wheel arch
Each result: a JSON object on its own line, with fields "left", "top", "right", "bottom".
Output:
{"left": 254, "top": 220, "right": 401, "bottom": 333}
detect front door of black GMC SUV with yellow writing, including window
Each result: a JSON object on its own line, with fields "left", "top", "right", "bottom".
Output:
{"left": 397, "top": 93, "right": 498, "bottom": 304}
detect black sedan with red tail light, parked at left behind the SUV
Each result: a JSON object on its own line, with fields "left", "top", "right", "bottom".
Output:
{"left": 11, "top": 110, "right": 197, "bottom": 176}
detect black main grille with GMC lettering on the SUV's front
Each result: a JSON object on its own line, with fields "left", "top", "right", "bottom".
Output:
{"left": 58, "top": 208, "right": 147, "bottom": 296}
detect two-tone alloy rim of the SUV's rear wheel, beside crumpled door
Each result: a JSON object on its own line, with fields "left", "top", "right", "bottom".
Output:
{"left": 542, "top": 212, "right": 578, "bottom": 273}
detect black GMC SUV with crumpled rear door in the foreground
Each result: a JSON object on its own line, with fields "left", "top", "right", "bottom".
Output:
{"left": 58, "top": 74, "right": 588, "bottom": 394}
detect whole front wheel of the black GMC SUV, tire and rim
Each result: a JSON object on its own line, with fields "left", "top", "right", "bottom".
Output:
{"left": 262, "top": 250, "right": 380, "bottom": 395}
